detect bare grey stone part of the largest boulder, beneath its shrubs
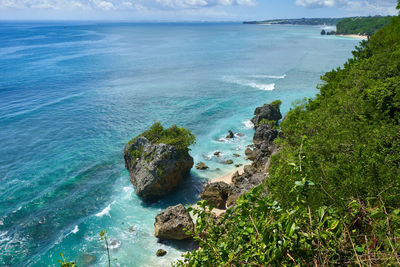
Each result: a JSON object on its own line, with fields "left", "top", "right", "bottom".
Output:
{"left": 124, "top": 136, "right": 193, "bottom": 200}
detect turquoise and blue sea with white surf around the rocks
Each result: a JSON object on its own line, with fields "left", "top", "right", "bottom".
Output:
{"left": 0, "top": 23, "right": 358, "bottom": 266}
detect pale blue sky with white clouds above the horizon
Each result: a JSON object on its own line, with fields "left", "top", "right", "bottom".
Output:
{"left": 0, "top": 0, "right": 397, "bottom": 22}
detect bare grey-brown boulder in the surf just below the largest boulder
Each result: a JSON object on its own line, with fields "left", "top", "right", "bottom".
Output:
{"left": 154, "top": 204, "right": 194, "bottom": 240}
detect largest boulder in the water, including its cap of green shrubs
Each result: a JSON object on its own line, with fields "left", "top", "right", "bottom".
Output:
{"left": 124, "top": 123, "right": 195, "bottom": 200}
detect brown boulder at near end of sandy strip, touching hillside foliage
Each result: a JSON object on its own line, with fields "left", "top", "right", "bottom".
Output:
{"left": 200, "top": 182, "right": 231, "bottom": 209}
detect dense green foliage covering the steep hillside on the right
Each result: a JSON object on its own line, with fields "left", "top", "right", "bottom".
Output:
{"left": 177, "top": 3, "right": 400, "bottom": 266}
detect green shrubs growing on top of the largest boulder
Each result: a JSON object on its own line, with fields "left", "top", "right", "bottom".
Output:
{"left": 129, "top": 122, "right": 196, "bottom": 151}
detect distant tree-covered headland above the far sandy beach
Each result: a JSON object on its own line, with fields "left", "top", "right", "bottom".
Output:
{"left": 336, "top": 16, "right": 392, "bottom": 35}
